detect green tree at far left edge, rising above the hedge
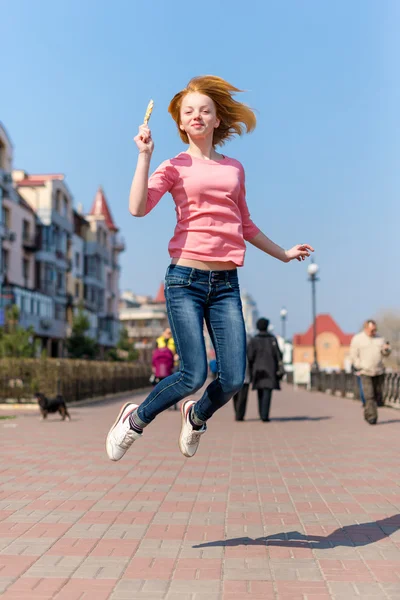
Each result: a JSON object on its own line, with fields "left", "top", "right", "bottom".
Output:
{"left": 0, "top": 304, "right": 37, "bottom": 358}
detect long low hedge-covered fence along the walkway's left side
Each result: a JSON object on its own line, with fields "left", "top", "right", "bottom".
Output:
{"left": 0, "top": 358, "right": 151, "bottom": 402}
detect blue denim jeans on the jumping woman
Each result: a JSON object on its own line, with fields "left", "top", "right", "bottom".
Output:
{"left": 137, "top": 265, "right": 246, "bottom": 426}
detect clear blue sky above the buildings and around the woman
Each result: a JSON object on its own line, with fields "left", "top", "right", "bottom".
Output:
{"left": 0, "top": 0, "right": 400, "bottom": 333}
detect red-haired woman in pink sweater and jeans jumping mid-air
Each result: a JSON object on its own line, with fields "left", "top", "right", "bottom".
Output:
{"left": 106, "top": 76, "right": 313, "bottom": 460}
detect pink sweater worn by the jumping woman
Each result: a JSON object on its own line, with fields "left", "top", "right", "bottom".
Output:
{"left": 146, "top": 152, "right": 260, "bottom": 266}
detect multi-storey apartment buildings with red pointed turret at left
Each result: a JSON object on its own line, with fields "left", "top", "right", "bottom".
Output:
{"left": 0, "top": 124, "right": 125, "bottom": 356}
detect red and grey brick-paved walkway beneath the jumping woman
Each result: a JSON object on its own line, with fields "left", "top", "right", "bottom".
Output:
{"left": 0, "top": 387, "right": 400, "bottom": 600}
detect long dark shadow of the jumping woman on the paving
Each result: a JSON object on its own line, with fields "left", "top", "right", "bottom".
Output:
{"left": 193, "top": 514, "right": 400, "bottom": 550}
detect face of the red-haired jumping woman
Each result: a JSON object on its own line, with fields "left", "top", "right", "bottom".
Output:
{"left": 180, "top": 92, "right": 220, "bottom": 140}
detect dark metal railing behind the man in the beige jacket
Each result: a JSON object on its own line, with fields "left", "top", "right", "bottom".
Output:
{"left": 286, "top": 371, "right": 400, "bottom": 409}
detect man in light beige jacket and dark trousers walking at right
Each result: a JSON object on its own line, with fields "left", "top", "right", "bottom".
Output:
{"left": 350, "top": 319, "right": 391, "bottom": 425}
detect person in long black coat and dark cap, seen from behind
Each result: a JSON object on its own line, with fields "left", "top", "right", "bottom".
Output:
{"left": 247, "top": 318, "right": 284, "bottom": 421}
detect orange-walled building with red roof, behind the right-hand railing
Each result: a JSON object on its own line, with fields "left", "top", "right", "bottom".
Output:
{"left": 293, "top": 314, "right": 354, "bottom": 370}
